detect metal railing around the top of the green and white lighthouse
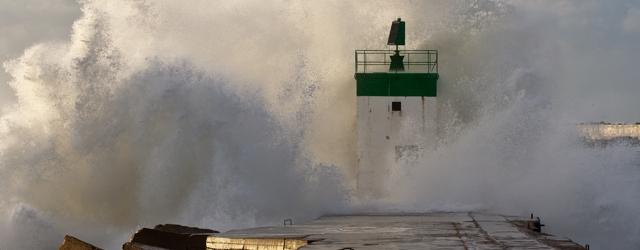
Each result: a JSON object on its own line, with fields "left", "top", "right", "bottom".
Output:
{"left": 355, "top": 50, "right": 438, "bottom": 73}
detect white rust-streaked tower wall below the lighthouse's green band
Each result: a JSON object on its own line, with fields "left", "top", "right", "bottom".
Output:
{"left": 357, "top": 96, "right": 437, "bottom": 198}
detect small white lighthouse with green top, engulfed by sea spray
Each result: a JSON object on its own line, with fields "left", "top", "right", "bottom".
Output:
{"left": 355, "top": 18, "right": 439, "bottom": 198}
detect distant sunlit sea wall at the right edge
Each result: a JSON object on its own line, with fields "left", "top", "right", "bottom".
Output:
{"left": 578, "top": 123, "right": 640, "bottom": 141}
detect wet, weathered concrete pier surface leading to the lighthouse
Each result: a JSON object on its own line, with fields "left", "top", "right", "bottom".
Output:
{"left": 207, "top": 213, "right": 584, "bottom": 250}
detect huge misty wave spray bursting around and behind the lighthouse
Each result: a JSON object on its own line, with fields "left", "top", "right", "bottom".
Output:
{"left": 0, "top": 0, "right": 640, "bottom": 249}
